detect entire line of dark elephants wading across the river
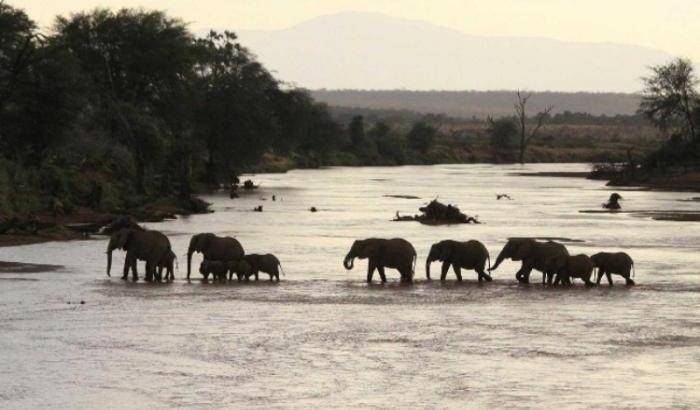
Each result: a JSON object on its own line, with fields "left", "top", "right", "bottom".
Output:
{"left": 107, "top": 227, "right": 634, "bottom": 286}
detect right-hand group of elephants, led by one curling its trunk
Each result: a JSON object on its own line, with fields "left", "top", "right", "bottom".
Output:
{"left": 343, "top": 238, "right": 634, "bottom": 286}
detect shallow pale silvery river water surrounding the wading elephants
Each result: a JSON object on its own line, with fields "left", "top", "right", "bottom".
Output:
{"left": 0, "top": 164, "right": 700, "bottom": 409}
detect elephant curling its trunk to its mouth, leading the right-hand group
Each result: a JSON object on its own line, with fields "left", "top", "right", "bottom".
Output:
{"left": 343, "top": 238, "right": 416, "bottom": 283}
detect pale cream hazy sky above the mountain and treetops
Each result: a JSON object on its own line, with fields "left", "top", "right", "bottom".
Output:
{"left": 12, "top": 0, "right": 700, "bottom": 62}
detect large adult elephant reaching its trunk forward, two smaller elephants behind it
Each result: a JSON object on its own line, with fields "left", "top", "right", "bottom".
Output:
{"left": 489, "top": 238, "right": 569, "bottom": 284}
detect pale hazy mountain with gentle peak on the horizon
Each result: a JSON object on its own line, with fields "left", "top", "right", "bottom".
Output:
{"left": 238, "top": 12, "right": 671, "bottom": 92}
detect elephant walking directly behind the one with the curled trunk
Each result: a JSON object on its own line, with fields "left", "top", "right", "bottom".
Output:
{"left": 425, "top": 240, "right": 492, "bottom": 282}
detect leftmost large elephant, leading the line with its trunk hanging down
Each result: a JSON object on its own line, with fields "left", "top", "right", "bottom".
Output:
{"left": 107, "top": 228, "right": 172, "bottom": 281}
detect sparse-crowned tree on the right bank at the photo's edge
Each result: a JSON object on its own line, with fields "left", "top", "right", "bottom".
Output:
{"left": 639, "top": 58, "right": 700, "bottom": 142}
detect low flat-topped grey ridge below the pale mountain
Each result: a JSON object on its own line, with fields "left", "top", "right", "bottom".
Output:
{"left": 312, "top": 90, "right": 639, "bottom": 118}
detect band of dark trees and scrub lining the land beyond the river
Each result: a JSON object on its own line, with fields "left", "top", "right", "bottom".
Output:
{"left": 0, "top": 2, "right": 700, "bottom": 237}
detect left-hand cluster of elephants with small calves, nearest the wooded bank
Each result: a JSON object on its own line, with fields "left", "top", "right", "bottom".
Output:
{"left": 107, "top": 227, "right": 284, "bottom": 282}
